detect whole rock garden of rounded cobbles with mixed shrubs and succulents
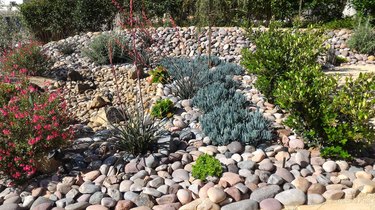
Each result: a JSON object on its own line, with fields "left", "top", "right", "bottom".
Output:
{"left": 0, "top": 0, "right": 375, "bottom": 210}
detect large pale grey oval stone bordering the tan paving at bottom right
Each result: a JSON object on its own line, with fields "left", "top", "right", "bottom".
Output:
{"left": 275, "top": 189, "right": 306, "bottom": 206}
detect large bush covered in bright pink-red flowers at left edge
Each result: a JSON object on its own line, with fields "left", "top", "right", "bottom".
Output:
{"left": 0, "top": 68, "right": 73, "bottom": 184}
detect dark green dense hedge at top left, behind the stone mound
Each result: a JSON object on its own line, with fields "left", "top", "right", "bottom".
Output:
{"left": 20, "top": 0, "right": 116, "bottom": 42}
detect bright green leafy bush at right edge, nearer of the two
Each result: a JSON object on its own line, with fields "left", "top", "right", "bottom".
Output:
{"left": 275, "top": 66, "right": 375, "bottom": 159}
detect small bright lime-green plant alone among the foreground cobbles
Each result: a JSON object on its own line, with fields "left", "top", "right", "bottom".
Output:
{"left": 191, "top": 154, "right": 223, "bottom": 181}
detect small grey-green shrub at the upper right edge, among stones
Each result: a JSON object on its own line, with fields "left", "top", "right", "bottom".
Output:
{"left": 348, "top": 20, "right": 375, "bottom": 54}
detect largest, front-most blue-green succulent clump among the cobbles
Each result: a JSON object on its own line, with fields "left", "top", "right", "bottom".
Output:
{"left": 200, "top": 102, "right": 273, "bottom": 146}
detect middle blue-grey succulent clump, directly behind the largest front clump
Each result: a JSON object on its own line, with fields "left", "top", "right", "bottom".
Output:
{"left": 193, "top": 82, "right": 246, "bottom": 112}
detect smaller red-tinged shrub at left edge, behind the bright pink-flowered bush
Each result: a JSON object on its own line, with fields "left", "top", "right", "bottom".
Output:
{"left": 0, "top": 42, "right": 51, "bottom": 76}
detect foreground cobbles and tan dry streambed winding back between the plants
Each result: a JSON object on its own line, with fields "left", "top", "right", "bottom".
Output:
{"left": 0, "top": 27, "right": 375, "bottom": 210}
